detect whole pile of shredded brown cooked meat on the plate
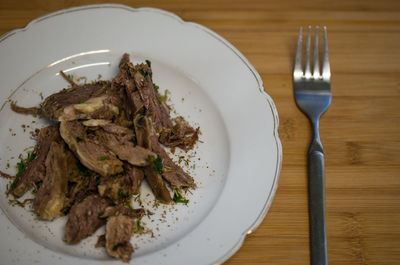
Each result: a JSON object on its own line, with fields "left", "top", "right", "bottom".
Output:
{"left": 4, "top": 54, "right": 199, "bottom": 262}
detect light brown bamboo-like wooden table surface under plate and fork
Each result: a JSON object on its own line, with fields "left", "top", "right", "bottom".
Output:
{"left": 0, "top": 0, "right": 400, "bottom": 265}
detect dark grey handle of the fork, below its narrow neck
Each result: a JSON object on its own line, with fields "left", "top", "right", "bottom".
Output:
{"left": 308, "top": 146, "right": 328, "bottom": 265}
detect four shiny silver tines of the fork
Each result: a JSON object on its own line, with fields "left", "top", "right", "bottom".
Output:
{"left": 293, "top": 26, "right": 331, "bottom": 80}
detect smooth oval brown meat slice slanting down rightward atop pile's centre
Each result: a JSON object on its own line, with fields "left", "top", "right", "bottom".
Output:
{"left": 60, "top": 121, "right": 123, "bottom": 176}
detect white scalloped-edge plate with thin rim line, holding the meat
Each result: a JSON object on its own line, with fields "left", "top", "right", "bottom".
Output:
{"left": 0, "top": 4, "right": 282, "bottom": 264}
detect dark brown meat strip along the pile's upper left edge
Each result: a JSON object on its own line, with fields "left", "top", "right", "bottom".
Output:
{"left": 41, "top": 81, "right": 110, "bottom": 120}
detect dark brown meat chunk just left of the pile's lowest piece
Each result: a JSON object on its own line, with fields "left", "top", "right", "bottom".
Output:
{"left": 65, "top": 195, "right": 110, "bottom": 244}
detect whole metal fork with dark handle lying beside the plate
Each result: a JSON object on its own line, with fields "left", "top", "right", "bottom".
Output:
{"left": 293, "top": 26, "right": 332, "bottom": 265}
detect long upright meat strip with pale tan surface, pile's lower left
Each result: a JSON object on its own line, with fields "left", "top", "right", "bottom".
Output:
{"left": 33, "top": 141, "right": 72, "bottom": 220}
